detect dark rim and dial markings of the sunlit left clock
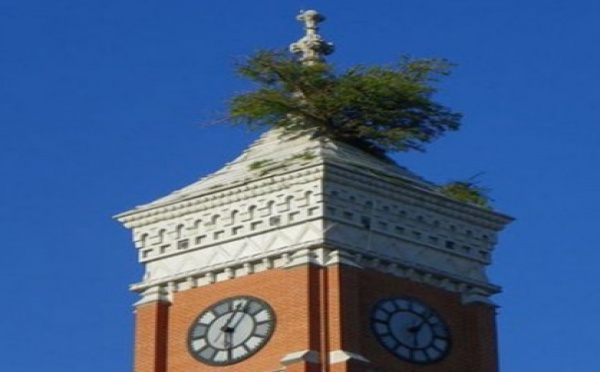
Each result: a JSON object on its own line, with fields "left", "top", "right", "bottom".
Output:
{"left": 186, "top": 295, "right": 277, "bottom": 367}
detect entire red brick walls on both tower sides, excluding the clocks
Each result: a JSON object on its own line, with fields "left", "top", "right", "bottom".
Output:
{"left": 135, "top": 266, "right": 497, "bottom": 372}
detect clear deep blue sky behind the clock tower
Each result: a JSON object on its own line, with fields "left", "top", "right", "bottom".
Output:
{"left": 0, "top": 0, "right": 600, "bottom": 372}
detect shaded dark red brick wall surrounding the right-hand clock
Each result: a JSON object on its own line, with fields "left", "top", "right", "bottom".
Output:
{"left": 330, "top": 266, "right": 498, "bottom": 372}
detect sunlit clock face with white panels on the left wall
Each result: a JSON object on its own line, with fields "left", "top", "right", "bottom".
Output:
{"left": 188, "top": 296, "right": 275, "bottom": 365}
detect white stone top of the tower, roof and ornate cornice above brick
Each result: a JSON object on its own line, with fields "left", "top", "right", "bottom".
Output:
{"left": 117, "top": 130, "right": 511, "bottom": 302}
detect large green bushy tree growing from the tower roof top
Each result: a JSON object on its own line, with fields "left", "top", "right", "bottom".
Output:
{"left": 227, "top": 51, "right": 461, "bottom": 156}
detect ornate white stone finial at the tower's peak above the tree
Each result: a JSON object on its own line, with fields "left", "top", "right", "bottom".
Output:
{"left": 290, "top": 10, "right": 334, "bottom": 64}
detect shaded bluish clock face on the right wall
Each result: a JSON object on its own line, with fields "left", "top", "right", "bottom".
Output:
{"left": 371, "top": 297, "right": 450, "bottom": 364}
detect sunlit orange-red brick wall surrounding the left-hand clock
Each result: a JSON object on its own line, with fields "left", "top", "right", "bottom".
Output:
{"left": 167, "top": 266, "right": 321, "bottom": 372}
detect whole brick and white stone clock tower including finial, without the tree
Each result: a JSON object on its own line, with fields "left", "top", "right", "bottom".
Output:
{"left": 117, "top": 11, "right": 511, "bottom": 372}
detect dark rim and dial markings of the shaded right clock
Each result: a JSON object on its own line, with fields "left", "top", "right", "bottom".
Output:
{"left": 369, "top": 296, "right": 452, "bottom": 365}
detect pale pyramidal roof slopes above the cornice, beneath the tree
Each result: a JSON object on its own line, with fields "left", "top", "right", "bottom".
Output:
{"left": 120, "top": 129, "right": 434, "bottom": 216}
